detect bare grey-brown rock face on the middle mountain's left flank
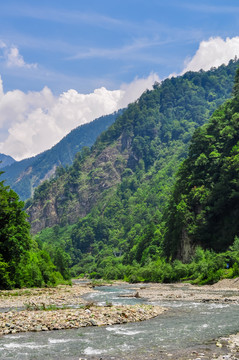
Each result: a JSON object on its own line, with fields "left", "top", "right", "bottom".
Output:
{"left": 27, "top": 136, "right": 132, "bottom": 233}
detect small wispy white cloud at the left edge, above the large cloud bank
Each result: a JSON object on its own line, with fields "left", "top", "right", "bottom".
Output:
{"left": 0, "top": 40, "right": 37, "bottom": 69}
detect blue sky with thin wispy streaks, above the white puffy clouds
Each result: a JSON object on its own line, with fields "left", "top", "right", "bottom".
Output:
{"left": 0, "top": 0, "right": 239, "bottom": 93}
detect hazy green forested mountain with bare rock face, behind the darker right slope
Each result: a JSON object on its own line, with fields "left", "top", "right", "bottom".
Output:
{"left": 30, "top": 60, "right": 239, "bottom": 281}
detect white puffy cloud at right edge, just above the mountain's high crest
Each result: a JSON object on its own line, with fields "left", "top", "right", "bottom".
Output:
{"left": 182, "top": 36, "right": 239, "bottom": 74}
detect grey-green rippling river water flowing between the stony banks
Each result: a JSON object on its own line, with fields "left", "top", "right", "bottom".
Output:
{"left": 0, "top": 286, "right": 239, "bottom": 360}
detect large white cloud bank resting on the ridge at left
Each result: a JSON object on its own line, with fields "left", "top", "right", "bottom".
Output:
{"left": 0, "top": 74, "right": 159, "bottom": 160}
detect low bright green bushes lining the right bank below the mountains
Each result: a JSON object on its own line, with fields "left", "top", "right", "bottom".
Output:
{"left": 80, "top": 247, "right": 239, "bottom": 285}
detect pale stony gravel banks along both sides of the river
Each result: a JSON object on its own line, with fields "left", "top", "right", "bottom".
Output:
{"left": 0, "top": 279, "right": 239, "bottom": 360}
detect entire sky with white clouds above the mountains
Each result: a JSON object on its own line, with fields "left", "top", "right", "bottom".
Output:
{"left": 0, "top": 0, "right": 239, "bottom": 160}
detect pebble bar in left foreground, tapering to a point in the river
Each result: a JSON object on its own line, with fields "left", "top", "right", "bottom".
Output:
{"left": 0, "top": 305, "right": 166, "bottom": 335}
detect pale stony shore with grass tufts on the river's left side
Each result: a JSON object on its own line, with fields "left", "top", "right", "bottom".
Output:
{"left": 0, "top": 284, "right": 166, "bottom": 335}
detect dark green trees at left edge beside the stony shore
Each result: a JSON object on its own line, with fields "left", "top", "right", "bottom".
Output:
{"left": 0, "top": 172, "right": 69, "bottom": 289}
